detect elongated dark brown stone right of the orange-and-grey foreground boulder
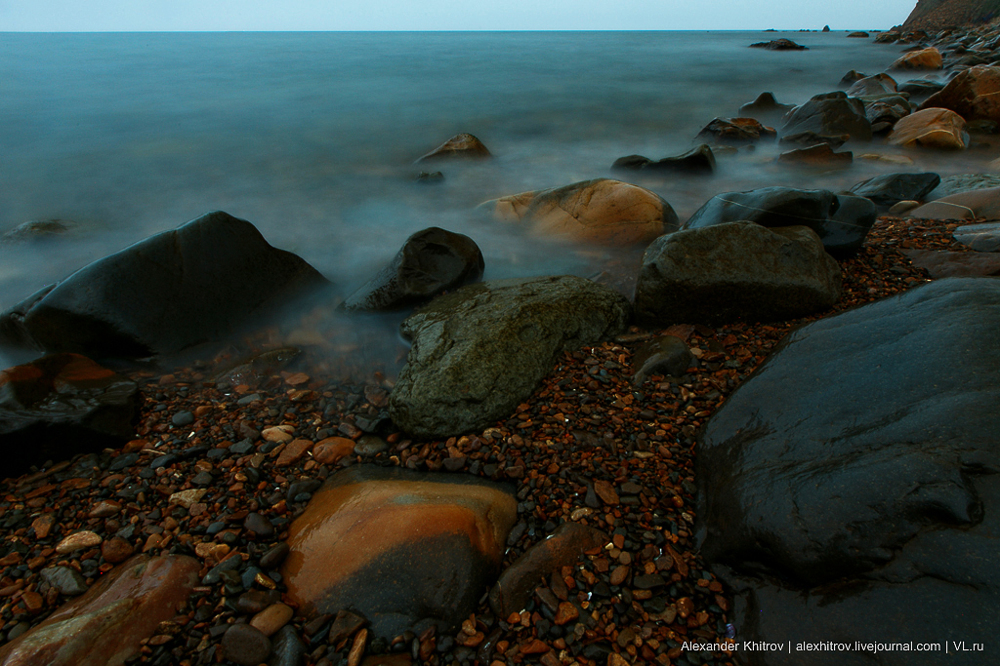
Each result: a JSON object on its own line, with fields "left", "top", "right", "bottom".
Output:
{"left": 489, "top": 523, "right": 608, "bottom": 617}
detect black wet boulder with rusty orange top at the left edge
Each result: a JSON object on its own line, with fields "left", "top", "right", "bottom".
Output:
{"left": 0, "top": 354, "right": 142, "bottom": 476}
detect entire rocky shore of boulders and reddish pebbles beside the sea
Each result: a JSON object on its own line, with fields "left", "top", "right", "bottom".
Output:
{"left": 0, "top": 18, "right": 1000, "bottom": 666}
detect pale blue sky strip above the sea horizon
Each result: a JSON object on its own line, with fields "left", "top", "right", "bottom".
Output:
{"left": 0, "top": 0, "right": 916, "bottom": 32}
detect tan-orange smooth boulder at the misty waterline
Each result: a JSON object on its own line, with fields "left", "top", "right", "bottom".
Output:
{"left": 480, "top": 178, "right": 677, "bottom": 245}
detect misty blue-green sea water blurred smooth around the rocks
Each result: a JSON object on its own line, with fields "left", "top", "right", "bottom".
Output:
{"left": 0, "top": 32, "right": 984, "bottom": 374}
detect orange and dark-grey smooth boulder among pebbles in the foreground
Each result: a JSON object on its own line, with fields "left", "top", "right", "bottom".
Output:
{"left": 282, "top": 466, "right": 517, "bottom": 640}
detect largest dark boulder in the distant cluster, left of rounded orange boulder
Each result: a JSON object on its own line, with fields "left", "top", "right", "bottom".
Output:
{"left": 780, "top": 90, "right": 872, "bottom": 145}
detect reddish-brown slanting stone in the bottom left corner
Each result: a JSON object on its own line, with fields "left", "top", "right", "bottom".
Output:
{"left": 0, "top": 555, "right": 201, "bottom": 666}
